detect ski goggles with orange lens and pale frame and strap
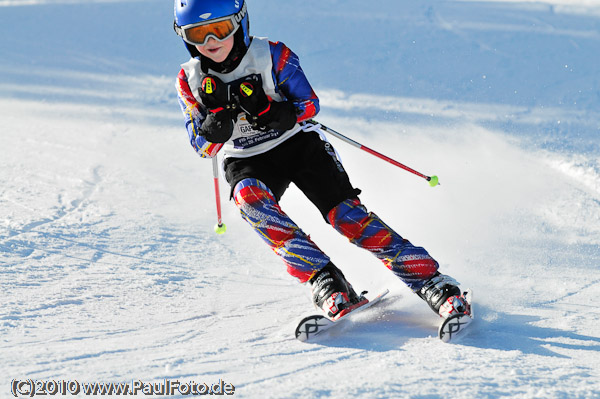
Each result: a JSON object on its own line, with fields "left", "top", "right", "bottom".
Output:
{"left": 174, "top": 3, "right": 246, "bottom": 46}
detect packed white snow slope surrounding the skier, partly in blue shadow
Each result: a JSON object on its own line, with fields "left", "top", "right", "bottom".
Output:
{"left": 0, "top": 0, "right": 600, "bottom": 399}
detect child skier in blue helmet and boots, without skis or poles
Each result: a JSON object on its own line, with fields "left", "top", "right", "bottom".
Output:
{"left": 174, "top": 0, "right": 469, "bottom": 320}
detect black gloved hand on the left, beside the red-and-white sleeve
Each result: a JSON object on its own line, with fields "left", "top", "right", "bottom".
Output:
{"left": 198, "top": 75, "right": 237, "bottom": 143}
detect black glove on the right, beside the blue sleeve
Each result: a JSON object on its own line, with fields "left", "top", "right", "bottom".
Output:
{"left": 237, "top": 75, "right": 296, "bottom": 130}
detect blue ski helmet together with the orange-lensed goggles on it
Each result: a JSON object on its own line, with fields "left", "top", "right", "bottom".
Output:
{"left": 174, "top": 0, "right": 250, "bottom": 48}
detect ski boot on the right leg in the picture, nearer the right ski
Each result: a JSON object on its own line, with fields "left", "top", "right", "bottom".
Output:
{"left": 417, "top": 272, "right": 471, "bottom": 319}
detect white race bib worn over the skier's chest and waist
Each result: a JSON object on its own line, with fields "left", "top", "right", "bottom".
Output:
{"left": 181, "top": 37, "right": 301, "bottom": 158}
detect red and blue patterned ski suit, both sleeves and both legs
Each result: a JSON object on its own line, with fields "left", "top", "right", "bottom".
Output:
{"left": 177, "top": 39, "right": 438, "bottom": 291}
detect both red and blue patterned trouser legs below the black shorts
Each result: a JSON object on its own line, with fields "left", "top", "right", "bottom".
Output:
{"left": 234, "top": 179, "right": 438, "bottom": 291}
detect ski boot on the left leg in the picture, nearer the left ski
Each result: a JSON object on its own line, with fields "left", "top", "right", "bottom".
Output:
{"left": 309, "top": 262, "right": 367, "bottom": 320}
